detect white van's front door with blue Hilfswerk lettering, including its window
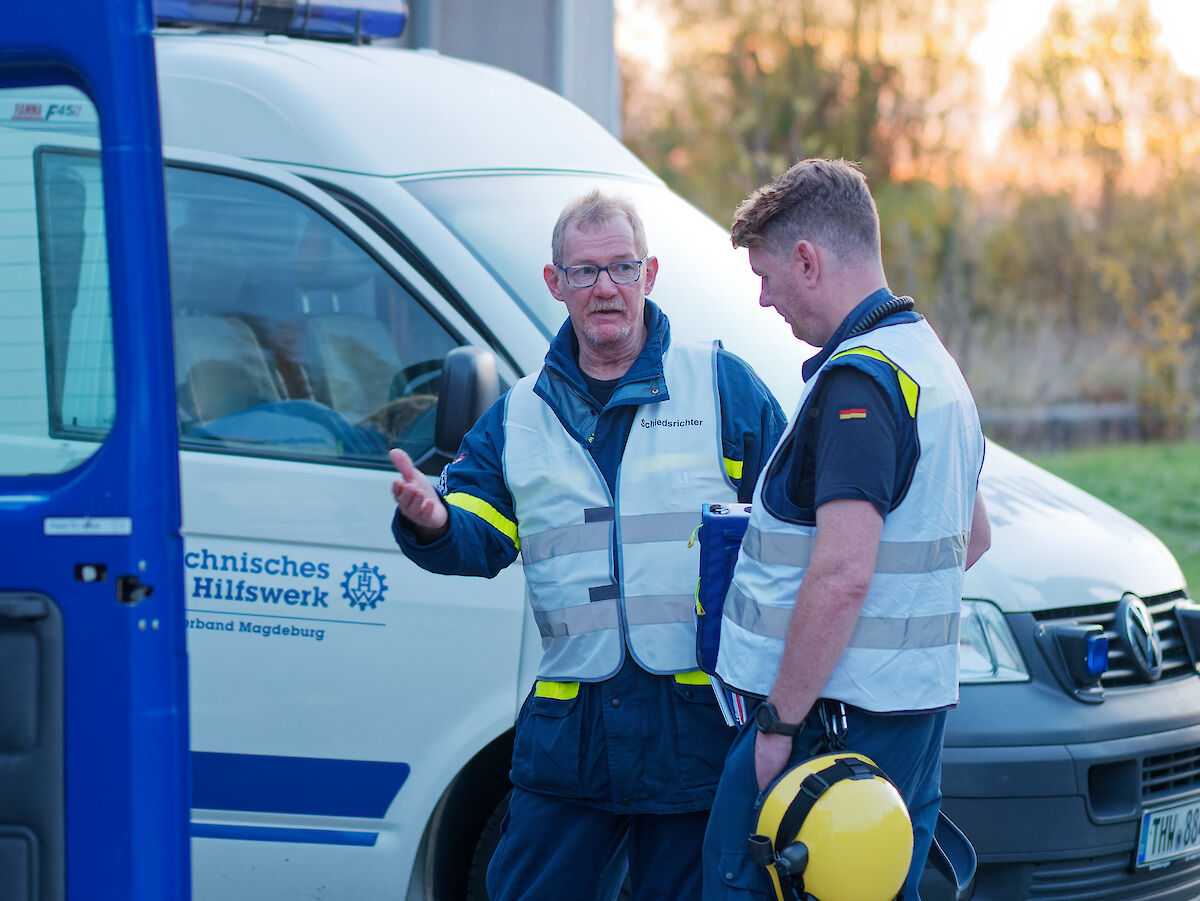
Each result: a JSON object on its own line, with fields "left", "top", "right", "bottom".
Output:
{"left": 166, "top": 148, "right": 528, "bottom": 901}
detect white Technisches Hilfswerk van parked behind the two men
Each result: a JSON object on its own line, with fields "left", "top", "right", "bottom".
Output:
{"left": 0, "top": 8, "right": 1200, "bottom": 901}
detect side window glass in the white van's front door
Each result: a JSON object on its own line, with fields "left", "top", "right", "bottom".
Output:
{"left": 167, "top": 167, "right": 460, "bottom": 463}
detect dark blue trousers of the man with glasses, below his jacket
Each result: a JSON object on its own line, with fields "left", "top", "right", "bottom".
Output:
{"left": 487, "top": 788, "right": 708, "bottom": 901}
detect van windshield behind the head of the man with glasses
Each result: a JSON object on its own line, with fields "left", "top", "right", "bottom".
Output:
{"left": 403, "top": 173, "right": 814, "bottom": 413}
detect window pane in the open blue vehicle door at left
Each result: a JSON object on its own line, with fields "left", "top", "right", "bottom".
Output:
{"left": 0, "top": 86, "right": 116, "bottom": 475}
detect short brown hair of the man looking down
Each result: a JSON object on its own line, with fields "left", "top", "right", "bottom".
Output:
{"left": 730, "top": 160, "right": 880, "bottom": 259}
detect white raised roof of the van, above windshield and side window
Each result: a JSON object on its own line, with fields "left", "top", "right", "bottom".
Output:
{"left": 155, "top": 32, "right": 659, "bottom": 181}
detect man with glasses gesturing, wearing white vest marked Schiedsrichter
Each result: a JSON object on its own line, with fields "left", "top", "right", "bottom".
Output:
{"left": 391, "top": 191, "right": 785, "bottom": 901}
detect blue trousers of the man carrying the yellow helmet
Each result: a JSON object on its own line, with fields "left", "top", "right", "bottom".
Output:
{"left": 703, "top": 707, "right": 946, "bottom": 901}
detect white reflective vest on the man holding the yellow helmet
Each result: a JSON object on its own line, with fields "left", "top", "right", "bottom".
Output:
{"left": 716, "top": 320, "right": 983, "bottom": 711}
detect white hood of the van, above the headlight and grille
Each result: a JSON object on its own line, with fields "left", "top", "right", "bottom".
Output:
{"left": 962, "top": 442, "right": 1183, "bottom": 613}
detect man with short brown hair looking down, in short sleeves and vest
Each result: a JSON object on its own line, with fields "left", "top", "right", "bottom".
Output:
{"left": 703, "top": 160, "right": 990, "bottom": 901}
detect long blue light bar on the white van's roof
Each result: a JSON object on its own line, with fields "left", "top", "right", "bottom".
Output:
{"left": 154, "top": 0, "right": 408, "bottom": 43}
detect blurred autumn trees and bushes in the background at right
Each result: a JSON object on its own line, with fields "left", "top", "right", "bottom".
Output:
{"left": 622, "top": 0, "right": 1200, "bottom": 437}
